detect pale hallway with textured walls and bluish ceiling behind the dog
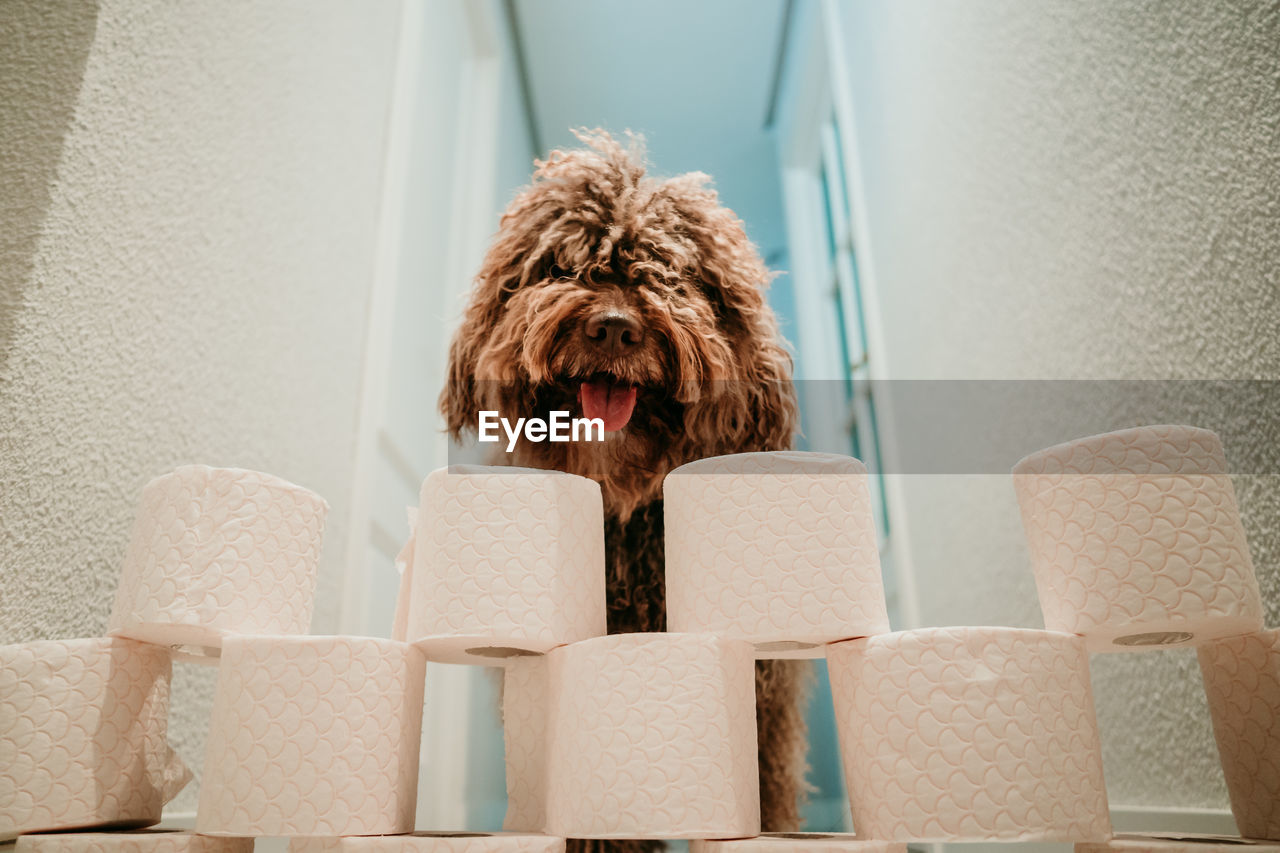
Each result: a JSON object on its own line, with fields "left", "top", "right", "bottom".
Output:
{"left": 0, "top": 0, "right": 1280, "bottom": 833}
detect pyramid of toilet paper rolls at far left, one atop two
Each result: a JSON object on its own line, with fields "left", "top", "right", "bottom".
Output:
{"left": 0, "top": 465, "right": 435, "bottom": 852}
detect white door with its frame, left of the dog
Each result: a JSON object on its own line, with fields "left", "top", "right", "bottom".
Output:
{"left": 340, "top": 0, "right": 502, "bottom": 829}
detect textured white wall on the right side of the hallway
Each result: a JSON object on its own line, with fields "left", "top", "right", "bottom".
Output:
{"left": 838, "top": 0, "right": 1280, "bottom": 807}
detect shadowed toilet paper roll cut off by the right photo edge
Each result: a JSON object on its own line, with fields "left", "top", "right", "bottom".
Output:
{"left": 1197, "top": 630, "right": 1280, "bottom": 840}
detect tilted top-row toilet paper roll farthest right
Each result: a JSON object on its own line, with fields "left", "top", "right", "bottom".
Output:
{"left": 1014, "top": 427, "right": 1262, "bottom": 652}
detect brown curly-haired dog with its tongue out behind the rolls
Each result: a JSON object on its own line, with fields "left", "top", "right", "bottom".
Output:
{"left": 440, "top": 131, "right": 810, "bottom": 850}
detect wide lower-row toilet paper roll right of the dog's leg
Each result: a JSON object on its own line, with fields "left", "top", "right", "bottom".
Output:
{"left": 827, "top": 628, "right": 1111, "bottom": 841}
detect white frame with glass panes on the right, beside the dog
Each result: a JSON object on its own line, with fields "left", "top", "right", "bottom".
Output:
{"left": 778, "top": 0, "right": 920, "bottom": 628}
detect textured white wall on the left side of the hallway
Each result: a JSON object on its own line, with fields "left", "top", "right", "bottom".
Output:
{"left": 0, "top": 0, "right": 399, "bottom": 811}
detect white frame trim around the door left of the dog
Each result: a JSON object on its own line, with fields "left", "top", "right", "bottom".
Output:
{"left": 338, "top": 0, "right": 500, "bottom": 829}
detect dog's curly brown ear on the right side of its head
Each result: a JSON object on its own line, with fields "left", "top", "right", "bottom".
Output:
{"left": 660, "top": 173, "right": 799, "bottom": 452}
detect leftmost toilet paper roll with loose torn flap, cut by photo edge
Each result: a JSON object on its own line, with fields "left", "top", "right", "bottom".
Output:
{"left": 0, "top": 638, "right": 191, "bottom": 840}
